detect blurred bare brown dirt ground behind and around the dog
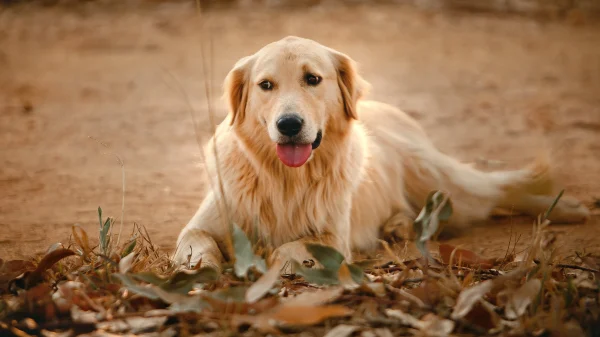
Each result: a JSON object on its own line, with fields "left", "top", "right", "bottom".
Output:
{"left": 0, "top": 2, "right": 600, "bottom": 259}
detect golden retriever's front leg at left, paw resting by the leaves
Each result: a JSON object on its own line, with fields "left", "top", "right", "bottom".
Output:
{"left": 173, "top": 192, "right": 228, "bottom": 272}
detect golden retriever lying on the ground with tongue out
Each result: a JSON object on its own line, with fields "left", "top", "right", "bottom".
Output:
{"left": 173, "top": 36, "right": 590, "bottom": 269}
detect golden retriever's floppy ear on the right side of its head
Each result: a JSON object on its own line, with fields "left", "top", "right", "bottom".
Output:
{"left": 330, "top": 49, "right": 369, "bottom": 119}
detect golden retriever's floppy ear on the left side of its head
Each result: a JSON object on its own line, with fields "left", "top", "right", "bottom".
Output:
{"left": 223, "top": 56, "right": 252, "bottom": 125}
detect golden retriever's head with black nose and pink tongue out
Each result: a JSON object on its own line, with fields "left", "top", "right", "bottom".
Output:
{"left": 225, "top": 36, "right": 367, "bottom": 167}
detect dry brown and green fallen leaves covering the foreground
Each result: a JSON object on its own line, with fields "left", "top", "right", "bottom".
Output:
{"left": 0, "top": 191, "right": 600, "bottom": 337}
